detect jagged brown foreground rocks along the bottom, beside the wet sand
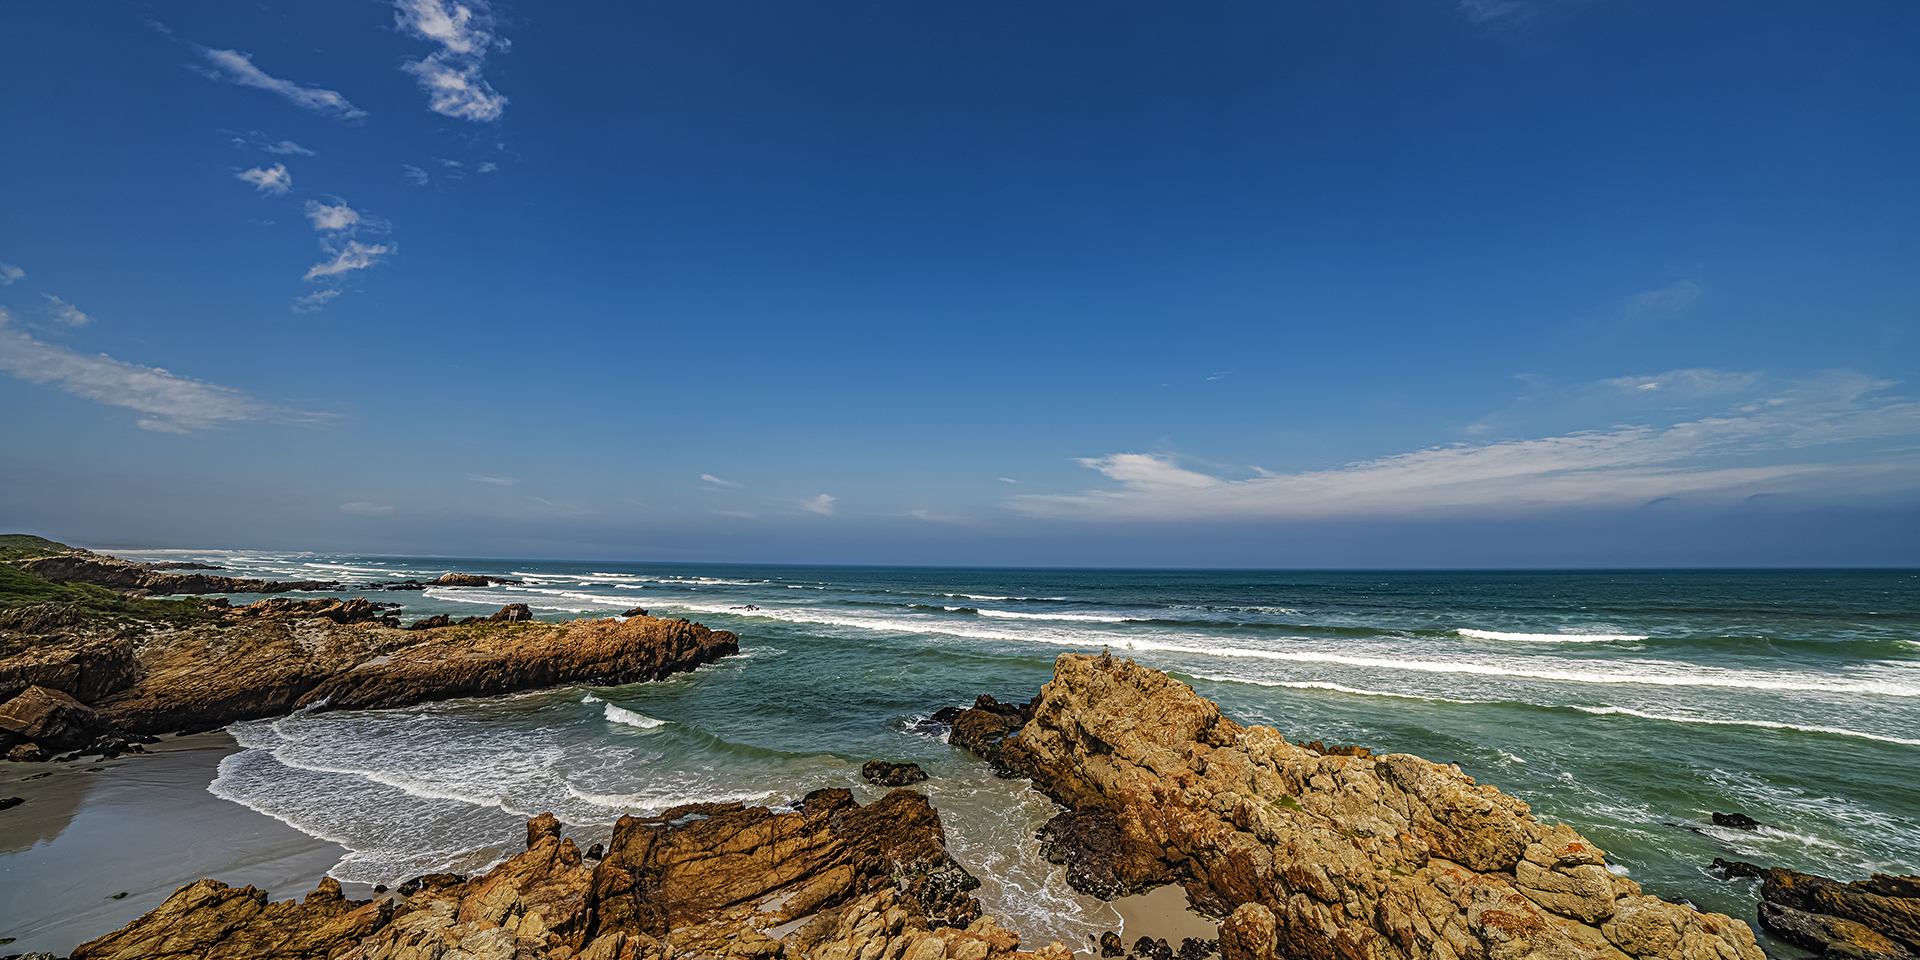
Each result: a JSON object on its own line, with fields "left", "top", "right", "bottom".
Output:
{"left": 73, "top": 789, "right": 1071, "bottom": 960}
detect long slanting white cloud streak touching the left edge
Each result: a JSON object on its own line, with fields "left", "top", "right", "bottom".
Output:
{"left": 0, "top": 309, "right": 323, "bottom": 434}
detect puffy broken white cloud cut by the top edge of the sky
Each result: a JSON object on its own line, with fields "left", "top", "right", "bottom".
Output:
{"left": 394, "top": 0, "right": 507, "bottom": 123}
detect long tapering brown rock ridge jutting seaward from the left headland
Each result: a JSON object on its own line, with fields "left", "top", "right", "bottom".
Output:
{"left": 80, "top": 616, "right": 739, "bottom": 733}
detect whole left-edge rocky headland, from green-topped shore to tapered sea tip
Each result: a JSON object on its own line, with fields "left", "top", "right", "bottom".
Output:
{"left": 0, "top": 557, "right": 739, "bottom": 760}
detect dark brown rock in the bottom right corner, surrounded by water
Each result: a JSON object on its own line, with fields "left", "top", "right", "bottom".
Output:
{"left": 1713, "top": 860, "right": 1920, "bottom": 960}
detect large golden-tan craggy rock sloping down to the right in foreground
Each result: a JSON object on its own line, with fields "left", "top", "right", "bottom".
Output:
{"left": 954, "top": 655, "right": 1764, "bottom": 960}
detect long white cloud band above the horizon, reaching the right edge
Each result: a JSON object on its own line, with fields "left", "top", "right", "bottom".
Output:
{"left": 1012, "top": 374, "right": 1920, "bottom": 520}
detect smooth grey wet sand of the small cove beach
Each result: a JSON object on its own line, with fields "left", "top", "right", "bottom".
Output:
{"left": 0, "top": 732, "right": 357, "bottom": 956}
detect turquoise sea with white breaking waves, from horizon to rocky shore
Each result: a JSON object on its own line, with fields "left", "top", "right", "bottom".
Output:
{"left": 120, "top": 553, "right": 1920, "bottom": 948}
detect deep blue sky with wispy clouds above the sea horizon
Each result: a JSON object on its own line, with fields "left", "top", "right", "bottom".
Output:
{"left": 0, "top": 0, "right": 1920, "bottom": 566}
